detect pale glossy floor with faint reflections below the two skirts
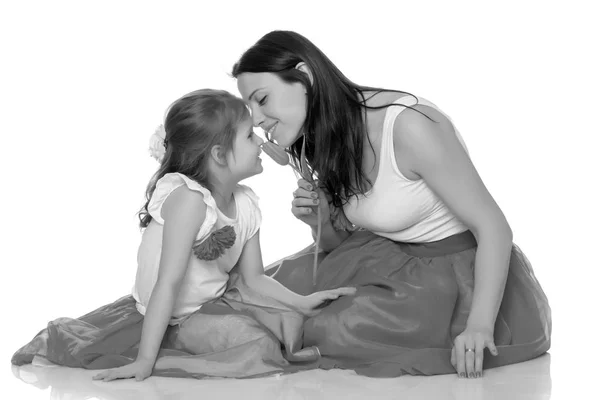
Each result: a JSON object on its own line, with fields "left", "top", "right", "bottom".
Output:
{"left": 13, "top": 354, "right": 552, "bottom": 400}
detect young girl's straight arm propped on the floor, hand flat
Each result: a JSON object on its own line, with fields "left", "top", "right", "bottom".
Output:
{"left": 94, "top": 185, "right": 206, "bottom": 380}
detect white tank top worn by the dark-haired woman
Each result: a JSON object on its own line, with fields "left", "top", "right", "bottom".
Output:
{"left": 344, "top": 96, "right": 467, "bottom": 243}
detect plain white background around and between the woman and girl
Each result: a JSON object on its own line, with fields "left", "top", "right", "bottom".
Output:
{"left": 0, "top": 0, "right": 600, "bottom": 398}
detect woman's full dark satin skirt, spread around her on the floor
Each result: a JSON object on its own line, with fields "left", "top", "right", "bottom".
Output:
{"left": 272, "top": 231, "right": 552, "bottom": 377}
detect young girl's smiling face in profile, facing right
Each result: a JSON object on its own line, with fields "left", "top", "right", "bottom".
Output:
{"left": 226, "top": 118, "right": 263, "bottom": 181}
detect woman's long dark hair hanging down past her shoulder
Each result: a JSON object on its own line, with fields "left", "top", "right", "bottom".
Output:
{"left": 231, "top": 31, "right": 416, "bottom": 207}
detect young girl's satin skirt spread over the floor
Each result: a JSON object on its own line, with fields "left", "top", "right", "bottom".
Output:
{"left": 12, "top": 269, "right": 320, "bottom": 378}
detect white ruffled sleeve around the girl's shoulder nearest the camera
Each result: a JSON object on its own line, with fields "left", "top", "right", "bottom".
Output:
{"left": 148, "top": 173, "right": 217, "bottom": 240}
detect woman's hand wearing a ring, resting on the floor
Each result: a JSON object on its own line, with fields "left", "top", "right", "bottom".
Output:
{"left": 450, "top": 326, "right": 498, "bottom": 378}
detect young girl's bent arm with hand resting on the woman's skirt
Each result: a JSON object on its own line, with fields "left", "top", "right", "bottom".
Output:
{"left": 238, "top": 230, "right": 356, "bottom": 315}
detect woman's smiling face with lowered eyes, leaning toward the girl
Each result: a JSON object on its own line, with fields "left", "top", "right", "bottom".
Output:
{"left": 237, "top": 72, "right": 306, "bottom": 147}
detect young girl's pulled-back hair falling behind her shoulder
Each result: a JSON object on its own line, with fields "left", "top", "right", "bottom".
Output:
{"left": 138, "top": 89, "right": 250, "bottom": 228}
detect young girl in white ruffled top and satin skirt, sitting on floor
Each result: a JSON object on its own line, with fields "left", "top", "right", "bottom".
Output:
{"left": 12, "top": 89, "right": 355, "bottom": 381}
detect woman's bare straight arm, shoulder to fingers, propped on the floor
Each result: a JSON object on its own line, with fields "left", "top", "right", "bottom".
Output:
{"left": 394, "top": 105, "right": 512, "bottom": 373}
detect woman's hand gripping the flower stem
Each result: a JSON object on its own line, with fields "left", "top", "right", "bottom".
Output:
{"left": 292, "top": 179, "right": 331, "bottom": 228}
